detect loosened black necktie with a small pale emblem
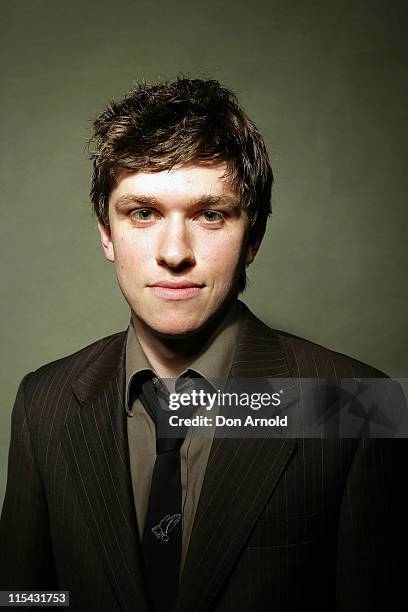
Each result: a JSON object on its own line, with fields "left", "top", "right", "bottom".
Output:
{"left": 140, "top": 379, "right": 185, "bottom": 612}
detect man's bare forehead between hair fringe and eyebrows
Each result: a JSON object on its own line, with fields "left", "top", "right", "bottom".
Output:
{"left": 110, "top": 162, "right": 234, "bottom": 203}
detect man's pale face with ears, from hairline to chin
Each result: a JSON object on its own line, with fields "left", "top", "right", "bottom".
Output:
{"left": 99, "top": 163, "right": 257, "bottom": 337}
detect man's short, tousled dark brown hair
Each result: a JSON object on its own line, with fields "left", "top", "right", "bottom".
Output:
{"left": 91, "top": 78, "right": 273, "bottom": 239}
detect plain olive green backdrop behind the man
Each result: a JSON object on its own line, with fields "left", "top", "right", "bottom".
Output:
{"left": 0, "top": 0, "right": 408, "bottom": 500}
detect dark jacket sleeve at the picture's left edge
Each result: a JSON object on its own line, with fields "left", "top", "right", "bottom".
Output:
{"left": 0, "top": 374, "right": 57, "bottom": 590}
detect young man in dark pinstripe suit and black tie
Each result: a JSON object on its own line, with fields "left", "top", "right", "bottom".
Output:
{"left": 0, "top": 79, "right": 405, "bottom": 612}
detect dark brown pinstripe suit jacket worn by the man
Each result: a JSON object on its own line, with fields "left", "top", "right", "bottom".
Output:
{"left": 0, "top": 304, "right": 407, "bottom": 612}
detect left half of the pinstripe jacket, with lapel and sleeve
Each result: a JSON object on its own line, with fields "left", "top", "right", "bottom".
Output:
{"left": 0, "top": 333, "right": 147, "bottom": 610}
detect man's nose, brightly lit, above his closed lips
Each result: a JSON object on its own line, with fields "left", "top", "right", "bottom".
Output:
{"left": 156, "top": 219, "right": 195, "bottom": 268}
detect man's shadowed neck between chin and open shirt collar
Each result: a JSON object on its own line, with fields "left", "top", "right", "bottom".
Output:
{"left": 132, "top": 302, "right": 235, "bottom": 378}
